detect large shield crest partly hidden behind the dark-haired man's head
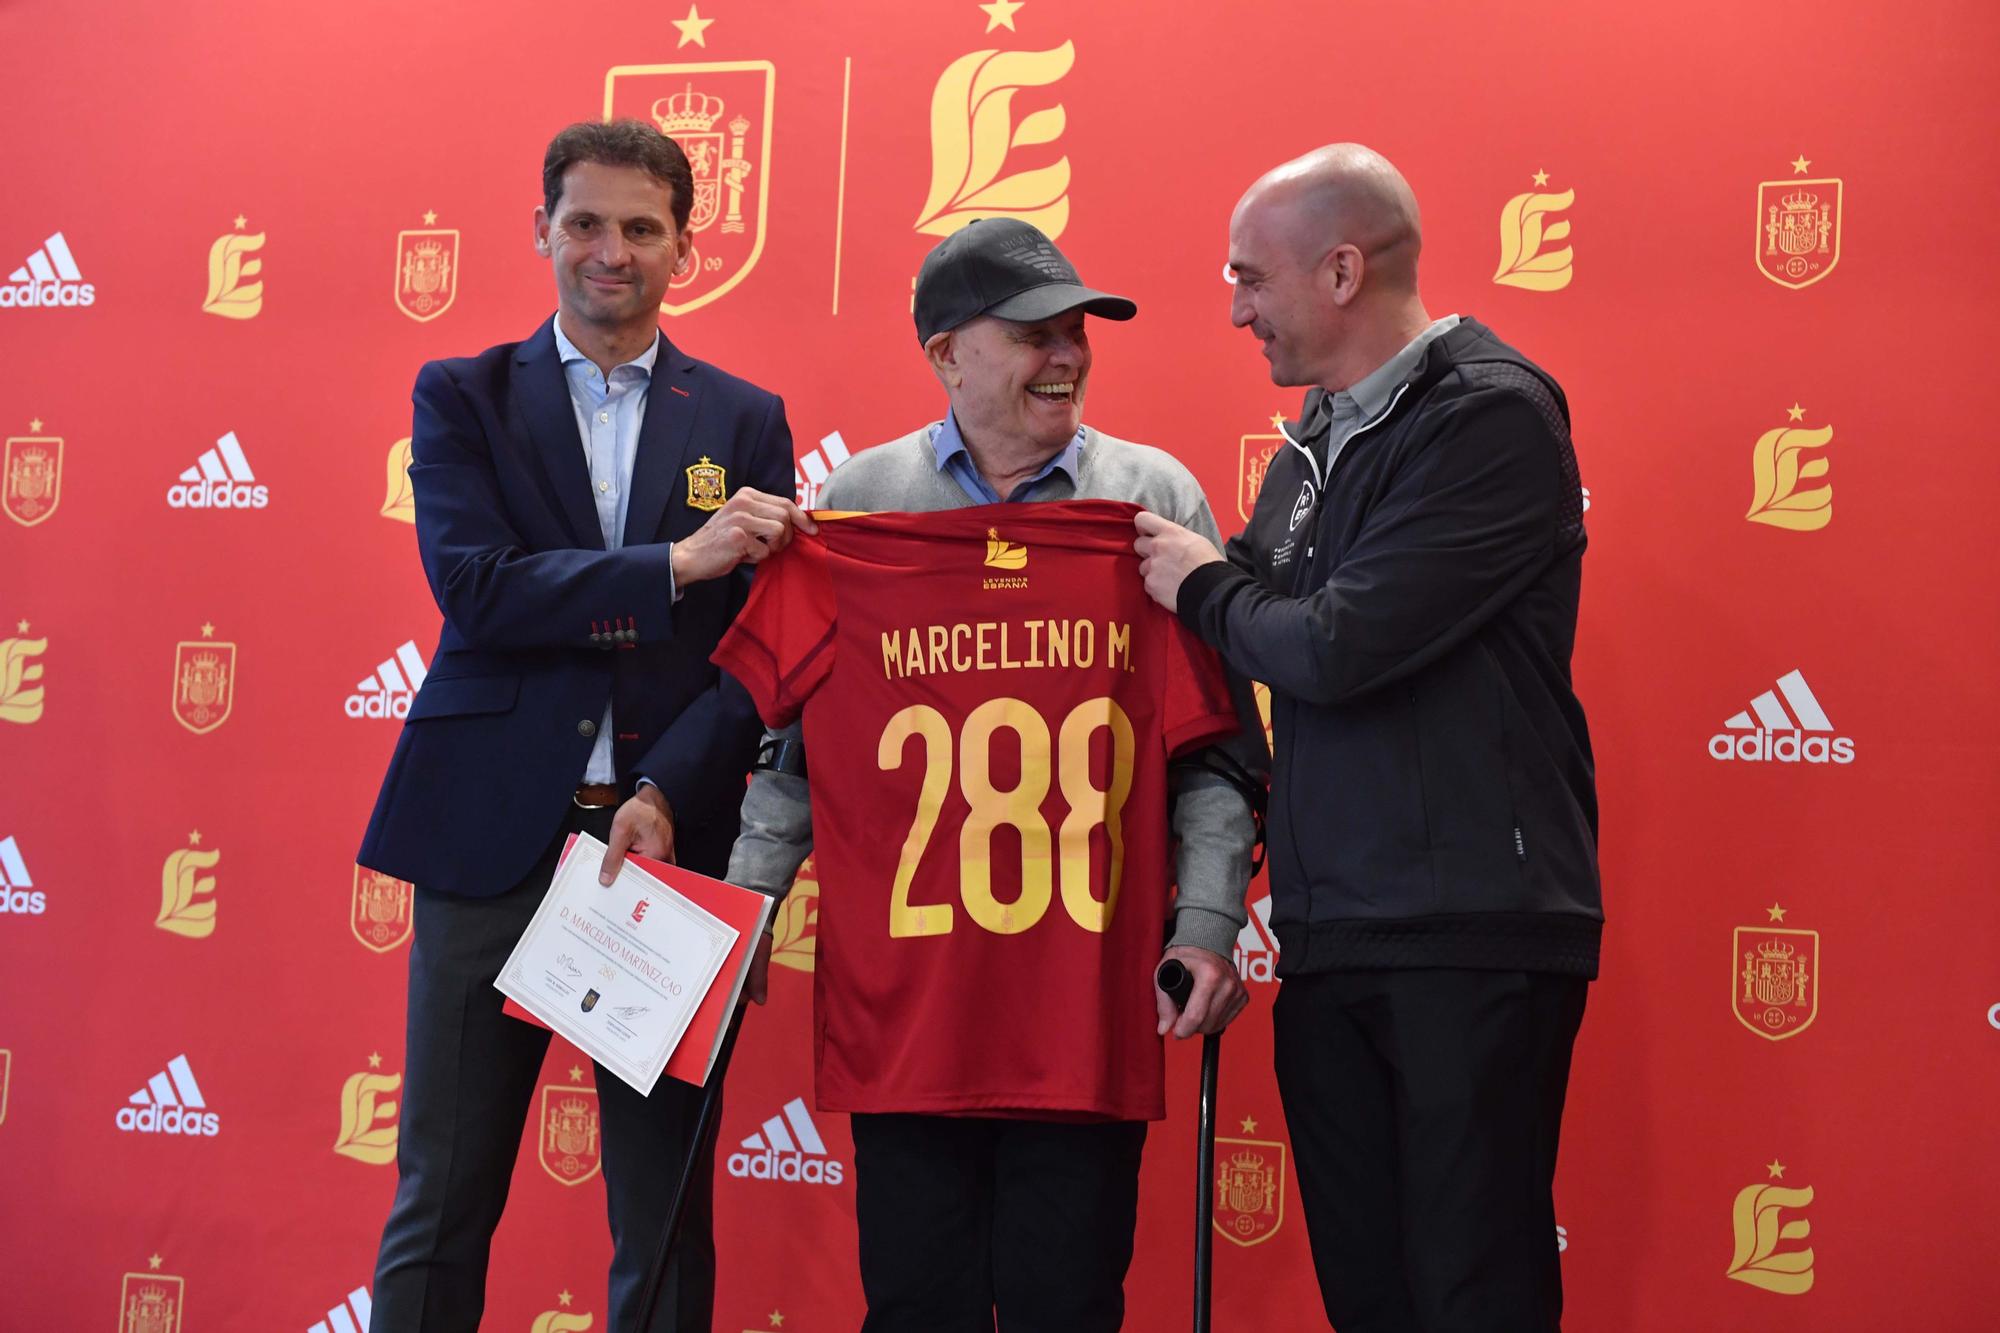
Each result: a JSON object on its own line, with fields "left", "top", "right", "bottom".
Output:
{"left": 604, "top": 60, "right": 778, "bottom": 314}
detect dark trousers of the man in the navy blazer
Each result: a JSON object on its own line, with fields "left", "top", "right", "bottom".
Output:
{"left": 370, "top": 807, "right": 716, "bottom": 1333}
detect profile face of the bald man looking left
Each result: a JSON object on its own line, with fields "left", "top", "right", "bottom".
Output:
{"left": 1230, "top": 192, "right": 1344, "bottom": 384}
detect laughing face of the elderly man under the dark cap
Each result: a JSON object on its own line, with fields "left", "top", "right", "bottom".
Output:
{"left": 926, "top": 310, "right": 1090, "bottom": 454}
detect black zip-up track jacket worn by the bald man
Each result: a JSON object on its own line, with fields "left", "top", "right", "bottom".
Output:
{"left": 1178, "top": 318, "right": 1604, "bottom": 977}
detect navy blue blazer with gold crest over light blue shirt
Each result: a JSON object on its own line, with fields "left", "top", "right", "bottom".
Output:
{"left": 358, "top": 320, "right": 792, "bottom": 897}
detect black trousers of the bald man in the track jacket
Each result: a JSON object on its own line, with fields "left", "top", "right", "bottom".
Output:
{"left": 1272, "top": 969, "right": 1588, "bottom": 1333}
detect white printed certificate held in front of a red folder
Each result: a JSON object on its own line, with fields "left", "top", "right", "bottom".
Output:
{"left": 494, "top": 833, "right": 736, "bottom": 1093}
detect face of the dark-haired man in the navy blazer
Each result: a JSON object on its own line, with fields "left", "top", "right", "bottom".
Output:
{"left": 534, "top": 162, "right": 692, "bottom": 332}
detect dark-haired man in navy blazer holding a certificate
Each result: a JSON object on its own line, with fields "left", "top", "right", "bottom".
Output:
{"left": 358, "top": 120, "right": 812, "bottom": 1333}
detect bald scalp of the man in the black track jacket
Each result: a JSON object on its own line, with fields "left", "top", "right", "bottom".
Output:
{"left": 1236, "top": 144, "right": 1424, "bottom": 290}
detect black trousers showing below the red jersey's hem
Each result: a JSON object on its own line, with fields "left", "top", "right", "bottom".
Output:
{"left": 852, "top": 1115, "right": 1146, "bottom": 1333}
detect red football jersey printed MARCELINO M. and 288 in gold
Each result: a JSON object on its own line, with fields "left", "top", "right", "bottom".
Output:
{"left": 714, "top": 500, "right": 1238, "bottom": 1119}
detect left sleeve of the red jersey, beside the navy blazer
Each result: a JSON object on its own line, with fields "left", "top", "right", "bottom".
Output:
{"left": 708, "top": 532, "right": 838, "bottom": 729}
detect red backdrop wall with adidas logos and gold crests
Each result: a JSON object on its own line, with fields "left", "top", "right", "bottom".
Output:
{"left": 0, "top": 0, "right": 2000, "bottom": 1333}
